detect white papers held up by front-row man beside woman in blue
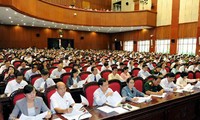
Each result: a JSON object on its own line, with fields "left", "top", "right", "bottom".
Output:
{"left": 106, "top": 91, "right": 123, "bottom": 107}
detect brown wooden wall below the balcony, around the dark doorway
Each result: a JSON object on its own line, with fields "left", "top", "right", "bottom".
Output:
{"left": 0, "top": 25, "right": 111, "bottom": 49}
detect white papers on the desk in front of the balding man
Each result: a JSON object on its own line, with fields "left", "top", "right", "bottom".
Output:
{"left": 62, "top": 108, "right": 92, "bottom": 120}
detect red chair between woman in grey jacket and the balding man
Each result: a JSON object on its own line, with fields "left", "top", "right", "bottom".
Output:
{"left": 44, "top": 85, "right": 56, "bottom": 109}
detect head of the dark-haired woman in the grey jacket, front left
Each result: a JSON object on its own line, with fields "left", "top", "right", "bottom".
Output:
{"left": 24, "top": 84, "right": 36, "bottom": 101}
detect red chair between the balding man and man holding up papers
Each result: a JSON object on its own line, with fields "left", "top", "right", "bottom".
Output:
{"left": 83, "top": 82, "right": 99, "bottom": 106}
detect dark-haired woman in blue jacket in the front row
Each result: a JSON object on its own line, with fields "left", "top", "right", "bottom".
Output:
{"left": 121, "top": 77, "right": 145, "bottom": 102}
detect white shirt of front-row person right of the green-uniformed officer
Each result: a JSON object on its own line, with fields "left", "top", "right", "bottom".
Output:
{"left": 160, "top": 78, "right": 177, "bottom": 92}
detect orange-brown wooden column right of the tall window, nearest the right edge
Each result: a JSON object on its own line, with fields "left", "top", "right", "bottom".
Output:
{"left": 170, "top": 0, "right": 180, "bottom": 54}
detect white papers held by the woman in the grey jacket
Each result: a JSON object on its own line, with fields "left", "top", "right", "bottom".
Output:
{"left": 19, "top": 111, "right": 48, "bottom": 120}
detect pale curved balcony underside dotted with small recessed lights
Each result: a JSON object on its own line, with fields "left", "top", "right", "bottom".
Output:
{"left": 0, "top": 7, "right": 151, "bottom": 33}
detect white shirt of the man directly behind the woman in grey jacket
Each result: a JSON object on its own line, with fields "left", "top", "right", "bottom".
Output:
{"left": 4, "top": 79, "right": 28, "bottom": 96}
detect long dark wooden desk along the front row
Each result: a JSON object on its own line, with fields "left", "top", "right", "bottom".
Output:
{"left": 52, "top": 90, "right": 200, "bottom": 120}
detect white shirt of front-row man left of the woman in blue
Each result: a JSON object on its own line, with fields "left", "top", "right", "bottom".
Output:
{"left": 93, "top": 88, "right": 113, "bottom": 106}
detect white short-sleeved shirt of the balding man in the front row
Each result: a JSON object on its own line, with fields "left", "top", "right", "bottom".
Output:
{"left": 50, "top": 91, "right": 75, "bottom": 113}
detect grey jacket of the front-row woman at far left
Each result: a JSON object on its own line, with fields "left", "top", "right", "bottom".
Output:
{"left": 9, "top": 97, "right": 50, "bottom": 120}
